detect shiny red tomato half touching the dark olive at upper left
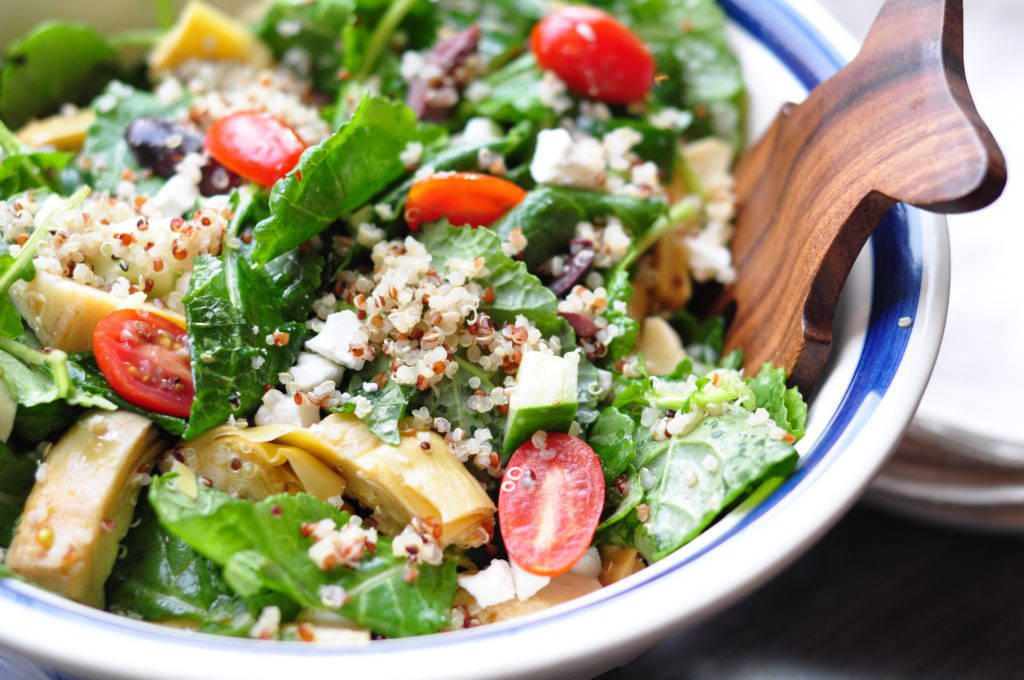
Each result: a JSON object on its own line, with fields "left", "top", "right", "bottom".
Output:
{"left": 206, "top": 111, "right": 306, "bottom": 186}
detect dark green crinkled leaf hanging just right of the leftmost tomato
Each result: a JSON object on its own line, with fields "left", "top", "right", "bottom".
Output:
{"left": 184, "top": 189, "right": 324, "bottom": 437}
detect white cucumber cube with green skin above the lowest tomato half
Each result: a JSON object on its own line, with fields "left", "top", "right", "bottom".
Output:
{"left": 502, "top": 351, "right": 580, "bottom": 458}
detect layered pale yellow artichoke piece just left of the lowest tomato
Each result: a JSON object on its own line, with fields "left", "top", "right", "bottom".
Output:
{"left": 278, "top": 414, "right": 496, "bottom": 548}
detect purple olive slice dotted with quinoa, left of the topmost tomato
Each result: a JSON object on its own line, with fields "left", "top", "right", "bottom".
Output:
{"left": 406, "top": 25, "right": 480, "bottom": 123}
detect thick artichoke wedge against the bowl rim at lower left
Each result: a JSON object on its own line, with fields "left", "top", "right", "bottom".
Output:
{"left": 6, "top": 411, "right": 161, "bottom": 606}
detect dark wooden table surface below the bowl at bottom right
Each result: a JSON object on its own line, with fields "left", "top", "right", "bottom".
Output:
{"left": 602, "top": 506, "right": 1024, "bottom": 680}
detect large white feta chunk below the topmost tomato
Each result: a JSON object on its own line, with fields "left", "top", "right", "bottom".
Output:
{"left": 529, "top": 128, "right": 605, "bottom": 188}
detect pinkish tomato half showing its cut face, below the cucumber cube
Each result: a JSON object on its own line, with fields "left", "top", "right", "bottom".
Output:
{"left": 498, "top": 433, "right": 604, "bottom": 577}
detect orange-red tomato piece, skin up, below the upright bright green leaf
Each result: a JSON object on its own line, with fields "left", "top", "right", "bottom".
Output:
{"left": 406, "top": 172, "right": 526, "bottom": 231}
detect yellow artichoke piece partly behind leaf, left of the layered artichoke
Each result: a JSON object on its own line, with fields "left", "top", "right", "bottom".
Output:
{"left": 160, "top": 425, "right": 345, "bottom": 501}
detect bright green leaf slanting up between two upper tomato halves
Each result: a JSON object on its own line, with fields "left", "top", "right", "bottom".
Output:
{"left": 253, "top": 96, "right": 436, "bottom": 264}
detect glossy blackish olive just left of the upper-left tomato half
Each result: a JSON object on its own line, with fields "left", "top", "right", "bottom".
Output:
{"left": 125, "top": 117, "right": 242, "bottom": 196}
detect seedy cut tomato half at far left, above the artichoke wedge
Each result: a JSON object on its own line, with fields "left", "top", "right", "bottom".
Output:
{"left": 92, "top": 309, "right": 196, "bottom": 418}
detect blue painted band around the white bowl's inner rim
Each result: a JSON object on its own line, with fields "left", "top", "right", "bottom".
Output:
{"left": 0, "top": 0, "right": 924, "bottom": 656}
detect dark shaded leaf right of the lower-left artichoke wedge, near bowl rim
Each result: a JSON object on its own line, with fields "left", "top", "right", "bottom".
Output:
{"left": 106, "top": 504, "right": 298, "bottom": 635}
